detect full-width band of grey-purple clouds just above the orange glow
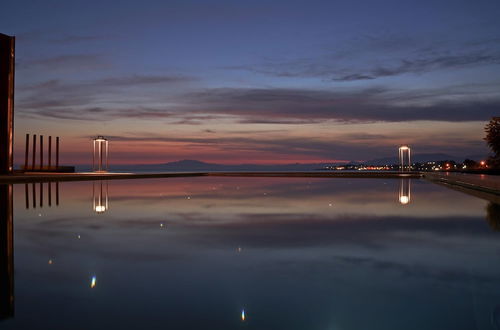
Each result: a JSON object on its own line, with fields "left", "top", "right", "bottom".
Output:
{"left": 17, "top": 81, "right": 500, "bottom": 125}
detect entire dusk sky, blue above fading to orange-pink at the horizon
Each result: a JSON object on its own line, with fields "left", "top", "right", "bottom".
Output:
{"left": 0, "top": 0, "right": 500, "bottom": 164}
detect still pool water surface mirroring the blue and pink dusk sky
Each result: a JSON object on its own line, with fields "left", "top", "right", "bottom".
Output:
{"left": 0, "top": 177, "right": 500, "bottom": 329}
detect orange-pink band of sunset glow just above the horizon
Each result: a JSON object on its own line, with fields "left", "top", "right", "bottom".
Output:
{"left": 14, "top": 118, "right": 484, "bottom": 169}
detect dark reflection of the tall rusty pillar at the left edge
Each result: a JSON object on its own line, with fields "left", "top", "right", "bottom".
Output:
{"left": 0, "top": 185, "right": 14, "bottom": 319}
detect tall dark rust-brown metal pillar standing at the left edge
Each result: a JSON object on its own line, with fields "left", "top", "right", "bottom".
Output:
{"left": 0, "top": 33, "right": 15, "bottom": 174}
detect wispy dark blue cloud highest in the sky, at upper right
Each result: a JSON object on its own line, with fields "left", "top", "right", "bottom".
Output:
{"left": 224, "top": 33, "right": 500, "bottom": 82}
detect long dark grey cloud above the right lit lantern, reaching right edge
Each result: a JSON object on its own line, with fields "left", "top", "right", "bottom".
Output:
{"left": 183, "top": 88, "right": 500, "bottom": 124}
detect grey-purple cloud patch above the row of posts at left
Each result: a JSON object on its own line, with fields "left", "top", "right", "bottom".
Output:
{"left": 16, "top": 75, "right": 195, "bottom": 120}
